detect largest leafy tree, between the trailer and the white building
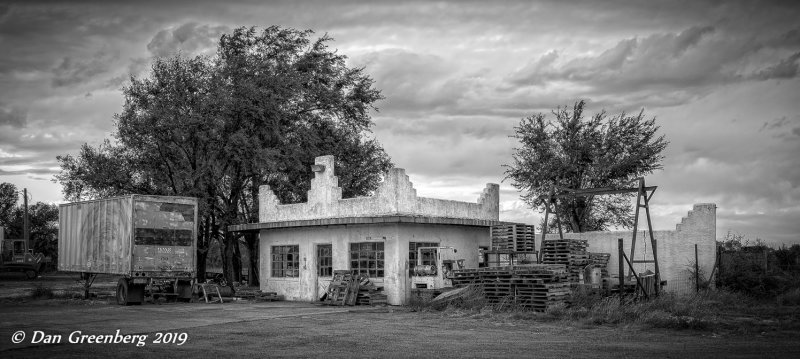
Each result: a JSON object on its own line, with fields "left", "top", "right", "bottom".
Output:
{"left": 57, "top": 26, "right": 391, "bottom": 281}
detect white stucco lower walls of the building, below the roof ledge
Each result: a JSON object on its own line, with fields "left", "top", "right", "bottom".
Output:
{"left": 259, "top": 223, "right": 489, "bottom": 305}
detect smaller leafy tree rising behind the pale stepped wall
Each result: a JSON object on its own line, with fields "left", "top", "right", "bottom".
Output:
{"left": 506, "top": 101, "right": 668, "bottom": 232}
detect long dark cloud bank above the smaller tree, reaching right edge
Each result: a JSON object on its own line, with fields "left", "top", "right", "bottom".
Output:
{"left": 505, "top": 26, "right": 800, "bottom": 106}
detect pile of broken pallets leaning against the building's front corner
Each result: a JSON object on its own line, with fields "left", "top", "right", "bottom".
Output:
{"left": 324, "top": 270, "right": 386, "bottom": 306}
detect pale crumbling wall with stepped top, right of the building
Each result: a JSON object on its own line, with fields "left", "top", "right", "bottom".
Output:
{"left": 536, "top": 203, "right": 717, "bottom": 290}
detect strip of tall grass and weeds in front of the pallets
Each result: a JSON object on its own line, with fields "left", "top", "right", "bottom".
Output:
{"left": 416, "top": 288, "right": 800, "bottom": 332}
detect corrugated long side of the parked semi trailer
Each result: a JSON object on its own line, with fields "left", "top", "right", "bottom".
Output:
{"left": 58, "top": 196, "right": 133, "bottom": 275}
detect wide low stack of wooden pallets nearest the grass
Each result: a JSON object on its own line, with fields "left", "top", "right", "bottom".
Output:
{"left": 453, "top": 264, "right": 570, "bottom": 311}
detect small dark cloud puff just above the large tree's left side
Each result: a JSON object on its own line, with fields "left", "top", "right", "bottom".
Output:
{"left": 147, "top": 22, "right": 231, "bottom": 57}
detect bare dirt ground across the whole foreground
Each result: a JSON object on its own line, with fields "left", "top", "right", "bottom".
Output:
{"left": 0, "top": 278, "right": 800, "bottom": 358}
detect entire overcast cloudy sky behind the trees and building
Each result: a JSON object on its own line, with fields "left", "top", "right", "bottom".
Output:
{"left": 0, "top": 0, "right": 800, "bottom": 244}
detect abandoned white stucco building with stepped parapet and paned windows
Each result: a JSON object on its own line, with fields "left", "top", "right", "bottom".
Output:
{"left": 228, "top": 156, "right": 499, "bottom": 305}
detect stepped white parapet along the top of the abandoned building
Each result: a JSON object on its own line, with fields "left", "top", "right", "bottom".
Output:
{"left": 259, "top": 156, "right": 500, "bottom": 223}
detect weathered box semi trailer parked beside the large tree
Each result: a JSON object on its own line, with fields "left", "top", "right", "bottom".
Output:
{"left": 58, "top": 195, "right": 197, "bottom": 305}
